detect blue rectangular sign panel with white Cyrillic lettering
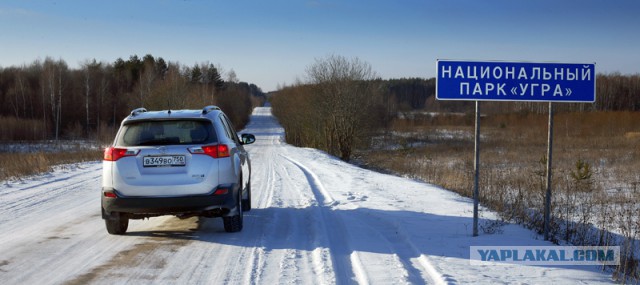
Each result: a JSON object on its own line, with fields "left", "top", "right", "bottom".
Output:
{"left": 436, "top": 60, "right": 596, "bottom": 102}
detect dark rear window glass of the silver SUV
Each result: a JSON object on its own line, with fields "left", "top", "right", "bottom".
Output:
{"left": 117, "top": 120, "right": 218, "bottom": 146}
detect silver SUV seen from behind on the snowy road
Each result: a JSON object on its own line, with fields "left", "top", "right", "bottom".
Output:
{"left": 102, "top": 106, "right": 255, "bottom": 235}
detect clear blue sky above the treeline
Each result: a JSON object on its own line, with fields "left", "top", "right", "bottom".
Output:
{"left": 0, "top": 0, "right": 640, "bottom": 91}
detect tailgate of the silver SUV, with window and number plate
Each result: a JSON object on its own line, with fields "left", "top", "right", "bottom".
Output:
{"left": 114, "top": 120, "right": 218, "bottom": 196}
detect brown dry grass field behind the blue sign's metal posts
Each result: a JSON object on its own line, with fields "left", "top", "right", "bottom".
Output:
{"left": 359, "top": 109, "right": 640, "bottom": 281}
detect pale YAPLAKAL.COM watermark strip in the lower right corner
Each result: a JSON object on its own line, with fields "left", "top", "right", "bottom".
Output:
{"left": 469, "top": 246, "right": 620, "bottom": 265}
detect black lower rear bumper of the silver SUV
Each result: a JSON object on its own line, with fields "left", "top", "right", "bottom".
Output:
{"left": 102, "top": 184, "right": 238, "bottom": 219}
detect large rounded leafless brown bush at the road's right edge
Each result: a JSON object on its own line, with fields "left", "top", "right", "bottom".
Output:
{"left": 272, "top": 55, "right": 386, "bottom": 160}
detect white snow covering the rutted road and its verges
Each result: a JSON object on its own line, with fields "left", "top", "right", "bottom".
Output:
{"left": 0, "top": 107, "right": 612, "bottom": 284}
